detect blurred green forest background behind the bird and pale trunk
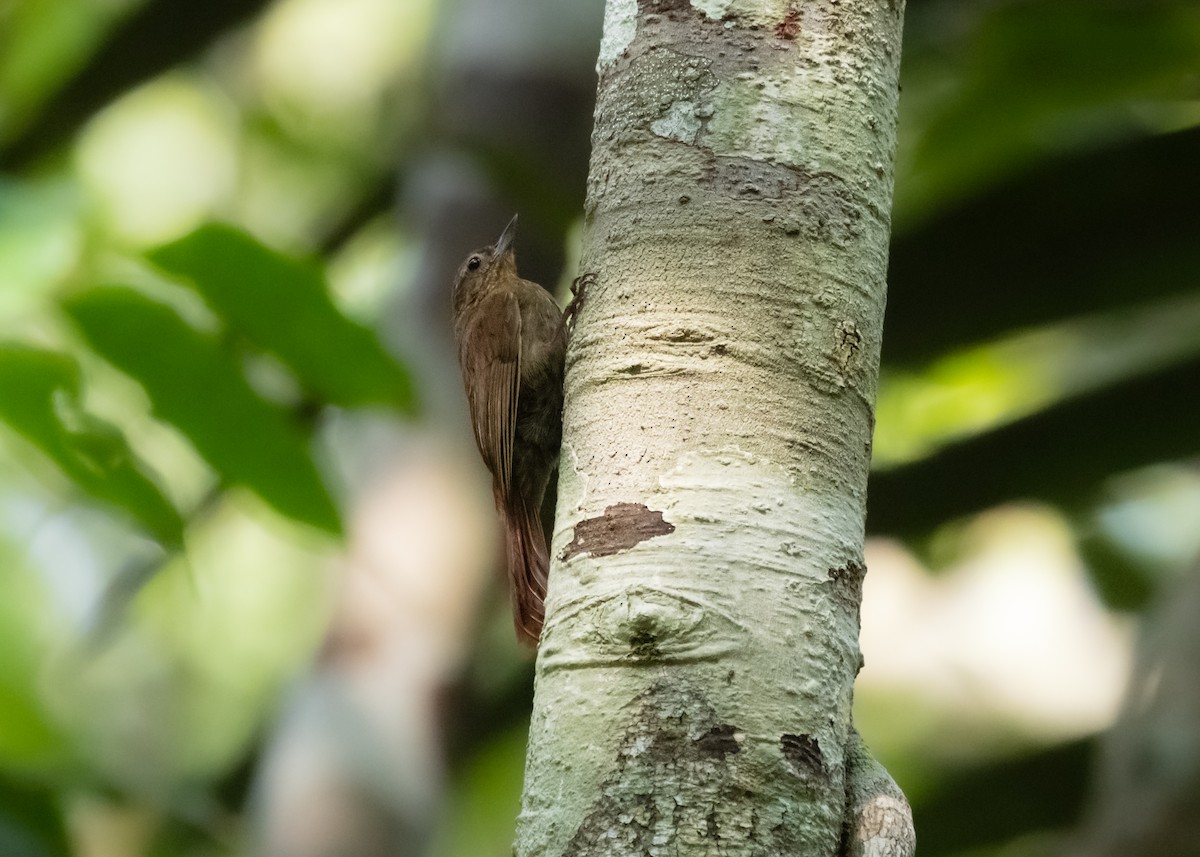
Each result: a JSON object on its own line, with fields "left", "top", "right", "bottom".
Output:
{"left": 0, "top": 0, "right": 1200, "bottom": 857}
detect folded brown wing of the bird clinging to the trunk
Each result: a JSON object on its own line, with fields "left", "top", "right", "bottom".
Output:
{"left": 460, "top": 292, "right": 521, "bottom": 498}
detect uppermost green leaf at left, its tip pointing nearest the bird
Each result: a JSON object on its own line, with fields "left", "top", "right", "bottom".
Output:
{"left": 150, "top": 224, "right": 413, "bottom": 410}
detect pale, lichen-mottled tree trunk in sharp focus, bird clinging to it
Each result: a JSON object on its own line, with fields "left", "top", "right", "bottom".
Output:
{"left": 516, "top": 0, "right": 912, "bottom": 857}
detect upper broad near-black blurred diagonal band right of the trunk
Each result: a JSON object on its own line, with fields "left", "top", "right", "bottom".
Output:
{"left": 883, "top": 127, "right": 1200, "bottom": 365}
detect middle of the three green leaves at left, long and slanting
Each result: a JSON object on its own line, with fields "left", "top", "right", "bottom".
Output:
{"left": 64, "top": 286, "right": 341, "bottom": 533}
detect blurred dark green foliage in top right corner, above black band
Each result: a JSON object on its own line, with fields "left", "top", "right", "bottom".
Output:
{"left": 893, "top": 0, "right": 1200, "bottom": 223}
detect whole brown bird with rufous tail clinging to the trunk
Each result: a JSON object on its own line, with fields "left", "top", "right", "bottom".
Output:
{"left": 454, "top": 216, "right": 566, "bottom": 646}
